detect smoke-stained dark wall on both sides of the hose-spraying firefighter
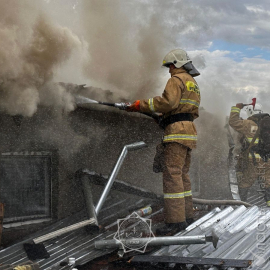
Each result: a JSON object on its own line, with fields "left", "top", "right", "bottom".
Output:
{"left": 0, "top": 105, "right": 229, "bottom": 218}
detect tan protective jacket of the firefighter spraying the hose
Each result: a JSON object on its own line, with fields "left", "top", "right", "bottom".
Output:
{"left": 140, "top": 68, "right": 200, "bottom": 149}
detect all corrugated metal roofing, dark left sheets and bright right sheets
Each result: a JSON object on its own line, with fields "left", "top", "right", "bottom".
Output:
{"left": 0, "top": 195, "right": 270, "bottom": 270}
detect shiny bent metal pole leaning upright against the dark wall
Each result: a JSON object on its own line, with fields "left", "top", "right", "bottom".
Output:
{"left": 96, "top": 142, "right": 147, "bottom": 215}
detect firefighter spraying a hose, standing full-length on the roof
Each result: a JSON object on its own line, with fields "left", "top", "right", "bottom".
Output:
{"left": 127, "top": 49, "right": 200, "bottom": 235}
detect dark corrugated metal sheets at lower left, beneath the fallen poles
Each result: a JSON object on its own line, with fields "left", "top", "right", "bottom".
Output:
{"left": 0, "top": 192, "right": 158, "bottom": 270}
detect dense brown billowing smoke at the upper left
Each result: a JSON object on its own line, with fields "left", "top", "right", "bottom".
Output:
{"left": 0, "top": 0, "right": 86, "bottom": 116}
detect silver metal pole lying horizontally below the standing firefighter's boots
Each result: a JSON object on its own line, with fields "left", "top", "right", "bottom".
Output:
{"left": 95, "top": 235, "right": 212, "bottom": 249}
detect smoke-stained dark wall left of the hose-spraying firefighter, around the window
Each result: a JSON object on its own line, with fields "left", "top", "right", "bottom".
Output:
{"left": 0, "top": 107, "right": 162, "bottom": 218}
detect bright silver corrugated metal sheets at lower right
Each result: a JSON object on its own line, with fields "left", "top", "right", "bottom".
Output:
{"left": 150, "top": 206, "right": 270, "bottom": 270}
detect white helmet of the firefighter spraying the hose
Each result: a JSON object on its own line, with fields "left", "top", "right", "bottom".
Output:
{"left": 162, "top": 49, "right": 200, "bottom": 77}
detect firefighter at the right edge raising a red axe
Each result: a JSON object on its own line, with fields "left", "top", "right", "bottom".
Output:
{"left": 229, "top": 103, "right": 270, "bottom": 206}
